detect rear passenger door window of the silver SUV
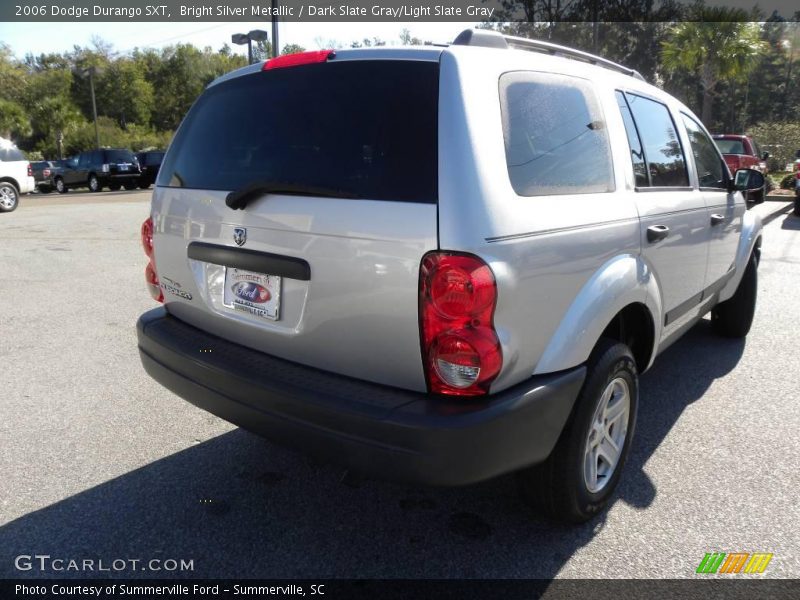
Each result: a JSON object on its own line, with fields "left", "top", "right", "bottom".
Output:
{"left": 625, "top": 94, "right": 689, "bottom": 187}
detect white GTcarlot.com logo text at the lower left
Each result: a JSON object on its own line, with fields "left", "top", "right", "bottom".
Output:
{"left": 14, "top": 554, "right": 194, "bottom": 573}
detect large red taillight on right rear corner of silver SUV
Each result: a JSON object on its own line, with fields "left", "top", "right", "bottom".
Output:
{"left": 419, "top": 252, "right": 503, "bottom": 396}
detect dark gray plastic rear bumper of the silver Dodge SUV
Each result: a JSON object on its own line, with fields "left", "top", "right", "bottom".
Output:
{"left": 137, "top": 308, "right": 585, "bottom": 485}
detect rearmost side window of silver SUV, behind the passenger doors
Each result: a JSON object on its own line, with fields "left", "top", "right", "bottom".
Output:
{"left": 500, "top": 71, "right": 614, "bottom": 196}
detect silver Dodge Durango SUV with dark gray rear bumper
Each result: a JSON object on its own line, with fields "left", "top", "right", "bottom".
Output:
{"left": 138, "top": 31, "right": 763, "bottom": 522}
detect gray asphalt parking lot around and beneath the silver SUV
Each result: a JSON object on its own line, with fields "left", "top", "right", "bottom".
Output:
{"left": 0, "top": 192, "right": 800, "bottom": 578}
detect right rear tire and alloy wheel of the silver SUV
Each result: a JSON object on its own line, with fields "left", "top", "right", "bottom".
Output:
{"left": 518, "top": 338, "right": 639, "bottom": 523}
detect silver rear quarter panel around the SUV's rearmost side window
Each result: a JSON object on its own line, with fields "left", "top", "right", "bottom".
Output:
{"left": 439, "top": 47, "right": 659, "bottom": 391}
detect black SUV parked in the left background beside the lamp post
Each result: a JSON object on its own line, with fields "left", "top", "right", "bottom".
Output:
{"left": 54, "top": 148, "right": 141, "bottom": 194}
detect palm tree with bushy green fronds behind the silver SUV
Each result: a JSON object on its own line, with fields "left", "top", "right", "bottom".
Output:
{"left": 661, "top": 7, "right": 763, "bottom": 124}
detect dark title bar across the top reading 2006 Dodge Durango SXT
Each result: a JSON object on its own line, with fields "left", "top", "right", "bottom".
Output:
{"left": 0, "top": 0, "right": 800, "bottom": 23}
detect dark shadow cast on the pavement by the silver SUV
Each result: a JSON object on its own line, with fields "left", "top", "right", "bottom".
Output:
{"left": 0, "top": 321, "right": 744, "bottom": 578}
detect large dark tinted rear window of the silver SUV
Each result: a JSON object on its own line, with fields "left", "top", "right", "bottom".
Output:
{"left": 158, "top": 60, "right": 439, "bottom": 203}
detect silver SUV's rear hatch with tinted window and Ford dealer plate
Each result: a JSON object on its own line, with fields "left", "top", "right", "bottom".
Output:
{"left": 153, "top": 51, "right": 438, "bottom": 391}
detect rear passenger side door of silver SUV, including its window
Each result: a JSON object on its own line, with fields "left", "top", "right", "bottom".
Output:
{"left": 617, "top": 91, "right": 708, "bottom": 337}
